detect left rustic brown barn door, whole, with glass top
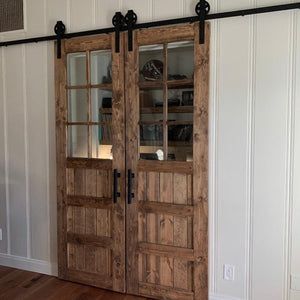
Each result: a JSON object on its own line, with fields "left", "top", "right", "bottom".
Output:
{"left": 56, "top": 34, "right": 125, "bottom": 292}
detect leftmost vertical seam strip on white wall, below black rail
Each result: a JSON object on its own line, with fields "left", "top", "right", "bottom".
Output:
{"left": 1, "top": 48, "right": 11, "bottom": 255}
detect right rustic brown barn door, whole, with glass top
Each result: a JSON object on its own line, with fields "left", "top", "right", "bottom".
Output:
{"left": 125, "top": 24, "right": 210, "bottom": 300}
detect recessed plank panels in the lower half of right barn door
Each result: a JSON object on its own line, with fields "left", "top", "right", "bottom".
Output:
{"left": 136, "top": 162, "right": 193, "bottom": 292}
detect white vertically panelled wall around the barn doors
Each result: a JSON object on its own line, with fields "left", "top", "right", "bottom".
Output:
{"left": 0, "top": 0, "right": 300, "bottom": 300}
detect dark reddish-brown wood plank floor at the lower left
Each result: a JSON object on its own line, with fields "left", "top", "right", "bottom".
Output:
{"left": 0, "top": 266, "right": 146, "bottom": 300}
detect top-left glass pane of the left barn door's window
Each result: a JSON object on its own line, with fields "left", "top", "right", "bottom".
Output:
{"left": 68, "top": 53, "right": 87, "bottom": 86}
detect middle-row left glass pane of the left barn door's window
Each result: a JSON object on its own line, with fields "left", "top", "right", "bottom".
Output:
{"left": 68, "top": 89, "right": 88, "bottom": 122}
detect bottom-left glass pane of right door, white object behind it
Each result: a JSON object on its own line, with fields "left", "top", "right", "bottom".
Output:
{"left": 140, "top": 124, "right": 164, "bottom": 160}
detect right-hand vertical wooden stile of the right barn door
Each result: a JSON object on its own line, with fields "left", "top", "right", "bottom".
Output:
{"left": 193, "top": 23, "right": 210, "bottom": 300}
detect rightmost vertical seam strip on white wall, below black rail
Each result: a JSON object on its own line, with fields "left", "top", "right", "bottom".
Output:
{"left": 283, "top": 8, "right": 297, "bottom": 300}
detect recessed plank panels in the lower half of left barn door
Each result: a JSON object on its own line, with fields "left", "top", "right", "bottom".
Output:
{"left": 67, "top": 164, "right": 112, "bottom": 282}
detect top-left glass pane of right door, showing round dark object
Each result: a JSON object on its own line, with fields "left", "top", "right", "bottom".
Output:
{"left": 139, "top": 45, "right": 164, "bottom": 81}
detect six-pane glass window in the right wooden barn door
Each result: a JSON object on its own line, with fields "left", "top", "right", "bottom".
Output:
{"left": 139, "top": 41, "right": 194, "bottom": 161}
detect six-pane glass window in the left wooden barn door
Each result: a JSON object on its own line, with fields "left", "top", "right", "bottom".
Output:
{"left": 66, "top": 50, "right": 112, "bottom": 159}
